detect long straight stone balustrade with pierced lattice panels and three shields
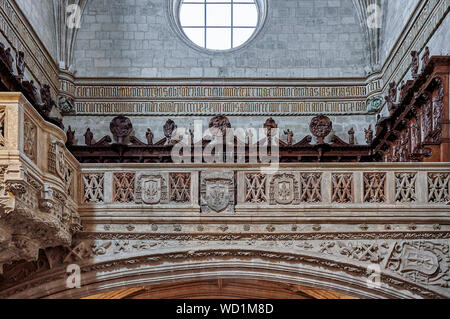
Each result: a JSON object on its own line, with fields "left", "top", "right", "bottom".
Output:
{"left": 79, "top": 163, "right": 450, "bottom": 216}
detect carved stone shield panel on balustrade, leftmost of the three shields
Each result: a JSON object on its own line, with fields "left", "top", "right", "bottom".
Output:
{"left": 135, "top": 173, "right": 169, "bottom": 205}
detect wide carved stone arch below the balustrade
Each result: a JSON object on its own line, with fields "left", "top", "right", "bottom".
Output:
{"left": 0, "top": 249, "right": 445, "bottom": 298}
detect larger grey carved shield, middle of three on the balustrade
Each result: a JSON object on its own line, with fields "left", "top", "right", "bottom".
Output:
{"left": 200, "top": 172, "right": 234, "bottom": 213}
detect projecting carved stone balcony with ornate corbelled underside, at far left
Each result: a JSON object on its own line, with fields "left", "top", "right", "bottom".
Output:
{"left": 0, "top": 93, "right": 81, "bottom": 269}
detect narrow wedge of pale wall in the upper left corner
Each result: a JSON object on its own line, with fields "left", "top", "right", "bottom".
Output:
{"left": 16, "top": 0, "right": 57, "bottom": 60}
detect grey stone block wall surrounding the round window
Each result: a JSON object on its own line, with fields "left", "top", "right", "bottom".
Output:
{"left": 75, "top": 0, "right": 367, "bottom": 78}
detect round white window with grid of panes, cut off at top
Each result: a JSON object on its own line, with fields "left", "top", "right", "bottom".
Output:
{"left": 179, "top": 0, "right": 260, "bottom": 50}
